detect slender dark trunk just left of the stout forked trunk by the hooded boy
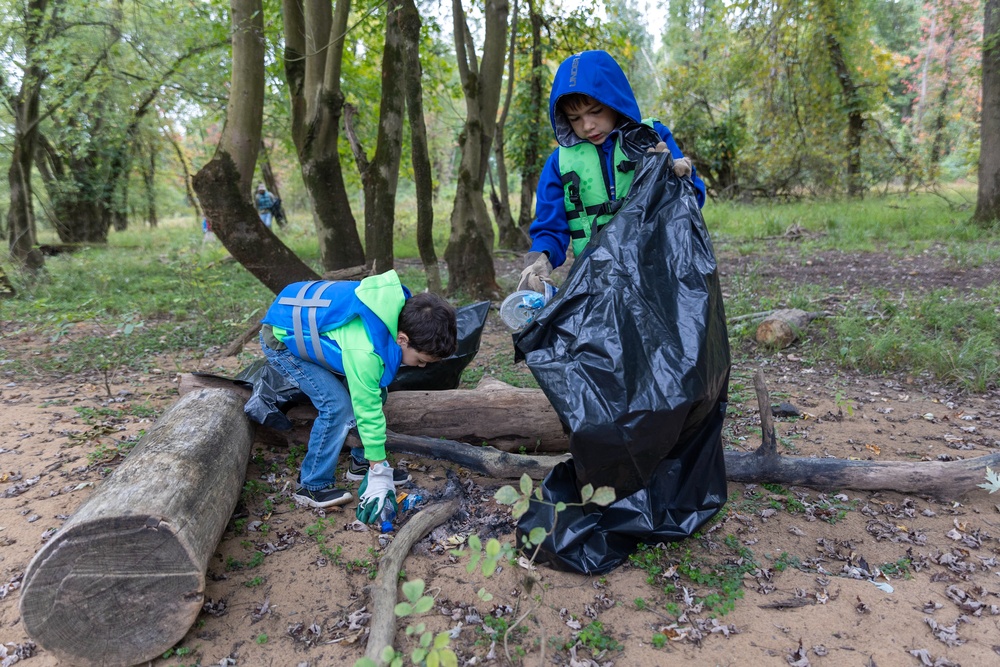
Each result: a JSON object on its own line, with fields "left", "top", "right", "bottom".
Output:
{"left": 399, "top": 0, "right": 444, "bottom": 294}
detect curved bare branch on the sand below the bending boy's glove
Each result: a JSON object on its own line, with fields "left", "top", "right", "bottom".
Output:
{"left": 365, "top": 498, "right": 460, "bottom": 665}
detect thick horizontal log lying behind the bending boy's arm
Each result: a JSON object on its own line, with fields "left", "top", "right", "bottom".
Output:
{"left": 178, "top": 374, "right": 569, "bottom": 453}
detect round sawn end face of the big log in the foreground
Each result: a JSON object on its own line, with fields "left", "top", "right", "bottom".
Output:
{"left": 20, "top": 515, "right": 205, "bottom": 665}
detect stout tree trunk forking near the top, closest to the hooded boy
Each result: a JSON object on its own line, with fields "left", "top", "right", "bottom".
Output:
{"left": 445, "top": 0, "right": 507, "bottom": 299}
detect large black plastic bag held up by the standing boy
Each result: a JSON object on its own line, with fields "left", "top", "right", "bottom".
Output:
{"left": 514, "top": 136, "right": 730, "bottom": 573}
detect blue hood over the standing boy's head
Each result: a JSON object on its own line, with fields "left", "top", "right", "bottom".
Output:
{"left": 549, "top": 51, "right": 642, "bottom": 146}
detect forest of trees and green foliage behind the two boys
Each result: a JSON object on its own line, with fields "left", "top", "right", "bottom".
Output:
{"left": 0, "top": 0, "right": 1000, "bottom": 296}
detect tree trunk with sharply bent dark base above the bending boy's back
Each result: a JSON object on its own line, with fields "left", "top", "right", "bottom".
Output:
{"left": 194, "top": 0, "right": 319, "bottom": 293}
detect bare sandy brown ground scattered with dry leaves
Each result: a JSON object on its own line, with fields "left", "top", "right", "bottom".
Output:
{"left": 0, "top": 248, "right": 1000, "bottom": 667}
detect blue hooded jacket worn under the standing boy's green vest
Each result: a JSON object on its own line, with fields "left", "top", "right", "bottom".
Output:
{"left": 529, "top": 51, "right": 705, "bottom": 268}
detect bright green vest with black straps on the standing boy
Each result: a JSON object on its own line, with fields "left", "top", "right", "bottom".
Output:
{"left": 559, "top": 118, "right": 654, "bottom": 255}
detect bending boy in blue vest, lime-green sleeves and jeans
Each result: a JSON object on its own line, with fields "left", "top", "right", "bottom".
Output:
{"left": 260, "top": 271, "right": 457, "bottom": 523}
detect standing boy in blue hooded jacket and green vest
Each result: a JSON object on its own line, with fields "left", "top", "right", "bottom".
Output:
{"left": 517, "top": 51, "right": 705, "bottom": 292}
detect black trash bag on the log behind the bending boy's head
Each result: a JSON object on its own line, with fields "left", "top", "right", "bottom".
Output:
{"left": 389, "top": 301, "right": 490, "bottom": 391}
